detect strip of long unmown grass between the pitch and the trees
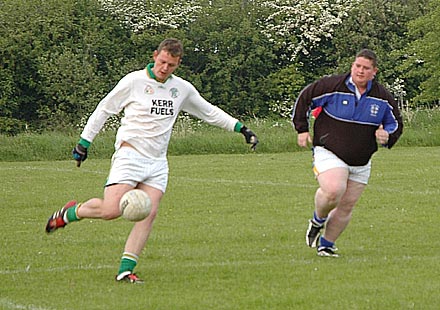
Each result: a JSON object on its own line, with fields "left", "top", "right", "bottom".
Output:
{"left": 0, "top": 108, "right": 440, "bottom": 161}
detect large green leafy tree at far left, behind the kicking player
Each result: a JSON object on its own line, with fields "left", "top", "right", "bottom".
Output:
{"left": 0, "top": 0, "right": 135, "bottom": 129}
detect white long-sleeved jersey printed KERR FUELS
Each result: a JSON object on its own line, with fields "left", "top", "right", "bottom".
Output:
{"left": 81, "top": 69, "right": 238, "bottom": 158}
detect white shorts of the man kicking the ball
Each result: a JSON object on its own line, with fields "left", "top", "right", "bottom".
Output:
{"left": 106, "top": 147, "right": 169, "bottom": 193}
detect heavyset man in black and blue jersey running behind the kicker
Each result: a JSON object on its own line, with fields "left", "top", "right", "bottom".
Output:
{"left": 292, "top": 49, "right": 403, "bottom": 257}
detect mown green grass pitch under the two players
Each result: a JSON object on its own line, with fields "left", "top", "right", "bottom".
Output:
{"left": 0, "top": 147, "right": 440, "bottom": 310}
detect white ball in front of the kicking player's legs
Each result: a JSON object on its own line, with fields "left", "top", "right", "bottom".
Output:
{"left": 119, "top": 189, "right": 151, "bottom": 222}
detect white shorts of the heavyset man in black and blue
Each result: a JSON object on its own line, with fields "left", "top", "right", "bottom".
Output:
{"left": 313, "top": 146, "right": 371, "bottom": 184}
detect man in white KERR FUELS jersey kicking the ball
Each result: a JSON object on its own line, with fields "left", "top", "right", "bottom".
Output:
{"left": 46, "top": 39, "right": 258, "bottom": 283}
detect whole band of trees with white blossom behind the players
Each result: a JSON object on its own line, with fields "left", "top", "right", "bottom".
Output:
{"left": 0, "top": 0, "right": 440, "bottom": 134}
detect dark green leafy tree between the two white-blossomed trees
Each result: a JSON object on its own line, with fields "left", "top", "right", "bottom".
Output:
{"left": 184, "top": 1, "right": 277, "bottom": 117}
